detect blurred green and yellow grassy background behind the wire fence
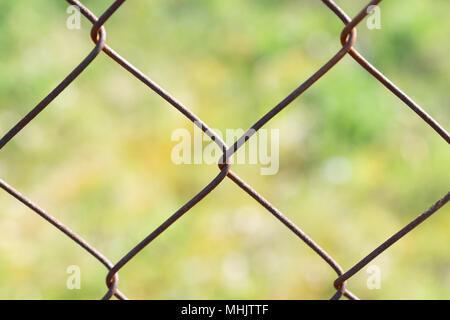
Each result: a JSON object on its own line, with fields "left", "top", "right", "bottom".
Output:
{"left": 0, "top": 0, "right": 450, "bottom": 299}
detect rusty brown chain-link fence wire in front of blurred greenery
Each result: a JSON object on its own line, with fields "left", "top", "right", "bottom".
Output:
{"left": 0, "top": 0, "right": 450, "bottom": 299}
